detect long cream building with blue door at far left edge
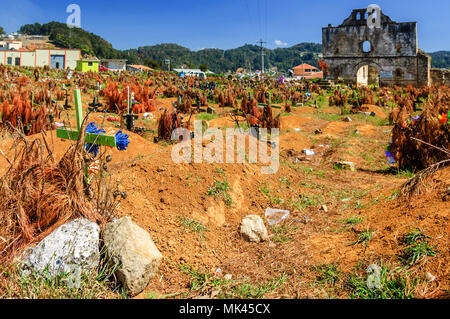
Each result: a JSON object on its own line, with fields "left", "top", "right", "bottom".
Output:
{"left": 0, "top": 48, "right": 81, "bottom": 70}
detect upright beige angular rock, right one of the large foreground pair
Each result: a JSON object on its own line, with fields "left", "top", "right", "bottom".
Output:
{"left": 103, "top": 217, "right": 163, "bottom": 296}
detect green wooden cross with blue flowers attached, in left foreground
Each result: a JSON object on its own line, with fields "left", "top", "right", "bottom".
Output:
{"left": 56, "top": 90, "right": 116, "bottom": 147}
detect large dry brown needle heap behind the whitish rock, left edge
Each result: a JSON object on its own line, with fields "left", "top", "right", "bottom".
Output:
{"left": 0, "top": 125, "right": 104, "bottom": 262}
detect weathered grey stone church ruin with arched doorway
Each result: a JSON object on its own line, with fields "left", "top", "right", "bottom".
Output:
{"left": 322, "top": 9, "right": 431, "bottom": 87}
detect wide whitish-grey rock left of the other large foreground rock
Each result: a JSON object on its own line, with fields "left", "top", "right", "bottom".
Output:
{"left": 19, "top": 218, "right": 100, "bottom": 276}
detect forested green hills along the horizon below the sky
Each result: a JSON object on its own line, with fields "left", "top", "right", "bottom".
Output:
{"left": 19, "top": 22, "right": 450, "bottom": 73}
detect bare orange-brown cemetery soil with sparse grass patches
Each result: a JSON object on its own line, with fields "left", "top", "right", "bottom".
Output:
{"left": 0, "top": 95, "right": 450, "bottom": 298}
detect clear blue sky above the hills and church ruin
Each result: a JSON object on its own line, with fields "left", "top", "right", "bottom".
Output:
{"left": 0, "top": 0, "right": 450, "bottom": 52}
